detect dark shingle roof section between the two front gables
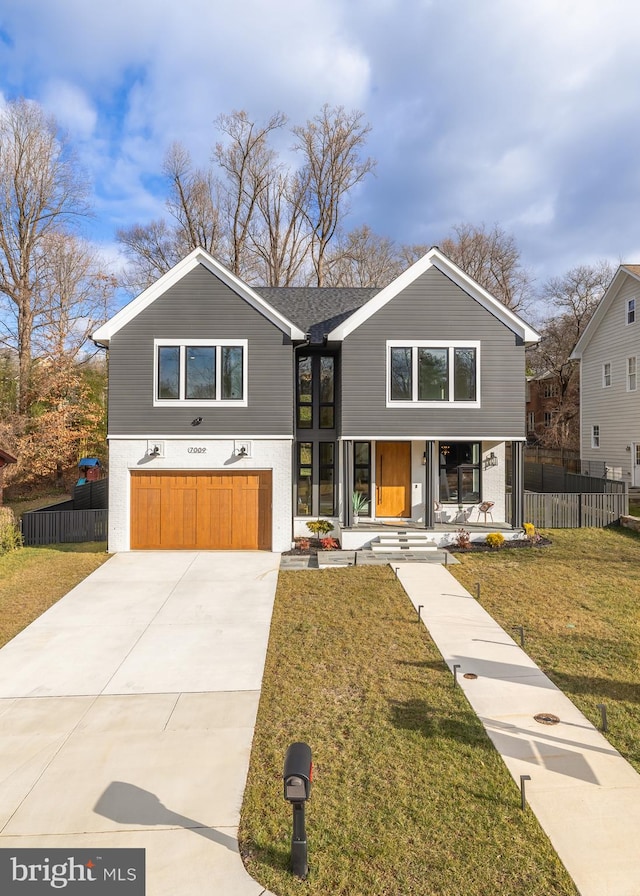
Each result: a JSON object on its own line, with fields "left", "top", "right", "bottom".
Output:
{"left": 254, "top": 286, "right": 380, "bottom": 342}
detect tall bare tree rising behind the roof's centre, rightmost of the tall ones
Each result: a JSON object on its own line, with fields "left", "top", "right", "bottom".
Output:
{"left": 293, "top": 104, "right": 375, "bottom": 286}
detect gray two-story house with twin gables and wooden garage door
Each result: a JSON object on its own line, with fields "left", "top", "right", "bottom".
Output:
{"left": 93, "top": 249, "right": 538, "bottom": 551}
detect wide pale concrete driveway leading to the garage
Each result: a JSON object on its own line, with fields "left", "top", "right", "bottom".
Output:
{"left": 0, "top": 552, "right": 280, "bottom": 896}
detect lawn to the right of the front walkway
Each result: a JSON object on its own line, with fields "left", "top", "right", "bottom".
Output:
{"left": 450, "top": 528, "right": 640, "bottom": 772}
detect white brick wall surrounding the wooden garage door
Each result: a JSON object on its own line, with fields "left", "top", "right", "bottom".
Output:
{"left": 109, "top": 437, "right": 292, "bottom": 552}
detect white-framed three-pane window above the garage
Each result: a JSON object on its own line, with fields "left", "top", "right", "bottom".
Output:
{"left": 153, "top": 338, "right": 248, "bottom": 407}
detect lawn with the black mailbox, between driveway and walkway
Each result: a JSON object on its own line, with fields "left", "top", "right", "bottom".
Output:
{"left": 239, "top": 567, "right": 576, "bottom": 896}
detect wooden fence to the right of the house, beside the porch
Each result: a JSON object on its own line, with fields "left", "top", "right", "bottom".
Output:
{"left": 507, "top": 492, "right": 629, "bottom": 529}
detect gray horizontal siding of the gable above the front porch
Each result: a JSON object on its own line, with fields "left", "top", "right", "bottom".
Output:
{"left": 341, "top": 268, "right": 525, "bottom": 439}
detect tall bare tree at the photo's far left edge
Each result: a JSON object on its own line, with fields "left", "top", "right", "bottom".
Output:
{"left": 0, "top": 99, "right": 88, "bottom": 411}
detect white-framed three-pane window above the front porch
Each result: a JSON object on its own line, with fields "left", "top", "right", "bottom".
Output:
{"left": 387, "top": 340, "right": 480, "bottom": 408}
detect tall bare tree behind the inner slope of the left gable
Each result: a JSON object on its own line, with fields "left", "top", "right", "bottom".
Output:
{"left": 214, "top": 111, "right": 287, "bottom": 279}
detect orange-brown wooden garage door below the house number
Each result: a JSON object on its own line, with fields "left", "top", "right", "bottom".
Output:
{"left": 131, "top": 470, "right": 271, "bottom": 551}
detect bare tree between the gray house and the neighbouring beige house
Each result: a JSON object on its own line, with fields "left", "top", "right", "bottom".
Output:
{"left": 527, "top": 261, "right": 613, "bottom": 448}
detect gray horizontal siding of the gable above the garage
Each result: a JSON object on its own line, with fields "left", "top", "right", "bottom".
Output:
{"left": 109, "top": 266, "right": 293, "bottom": 438}
